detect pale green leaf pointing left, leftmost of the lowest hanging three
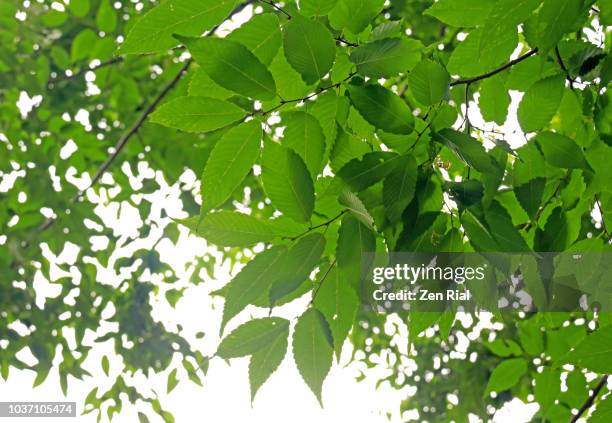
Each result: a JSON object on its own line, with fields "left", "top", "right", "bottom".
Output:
{"left": 216, "top": 317, "right": 289, "bottom": 359}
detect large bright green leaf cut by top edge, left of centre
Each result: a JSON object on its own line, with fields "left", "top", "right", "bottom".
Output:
{"left": 119, "top": 0, "right": 238, "bottom": 54}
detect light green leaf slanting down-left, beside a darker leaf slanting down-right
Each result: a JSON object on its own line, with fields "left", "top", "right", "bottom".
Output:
{"left": 202, "top": 120, "right": 263, "bottom": 210}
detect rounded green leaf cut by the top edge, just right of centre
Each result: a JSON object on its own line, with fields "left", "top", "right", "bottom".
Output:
{"left": 329, "top": 0, "right": 385, "bottom": 34}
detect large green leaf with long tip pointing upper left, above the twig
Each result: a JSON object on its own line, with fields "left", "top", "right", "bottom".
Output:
{"left": 177, "top": 36, "right": 276, "bottom": 100}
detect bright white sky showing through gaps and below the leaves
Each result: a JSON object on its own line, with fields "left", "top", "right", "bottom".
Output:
{"left": 5, "top": 1, "right": 612, "bottom": 423}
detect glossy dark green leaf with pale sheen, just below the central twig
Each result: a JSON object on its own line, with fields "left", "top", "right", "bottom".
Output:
{"left": 348, "top": 84, "right": 414, "bottom": 134}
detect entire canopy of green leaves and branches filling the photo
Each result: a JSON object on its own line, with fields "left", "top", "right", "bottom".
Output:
{"left": 0, "top": 0, "right": 612, "bottom": 422}
